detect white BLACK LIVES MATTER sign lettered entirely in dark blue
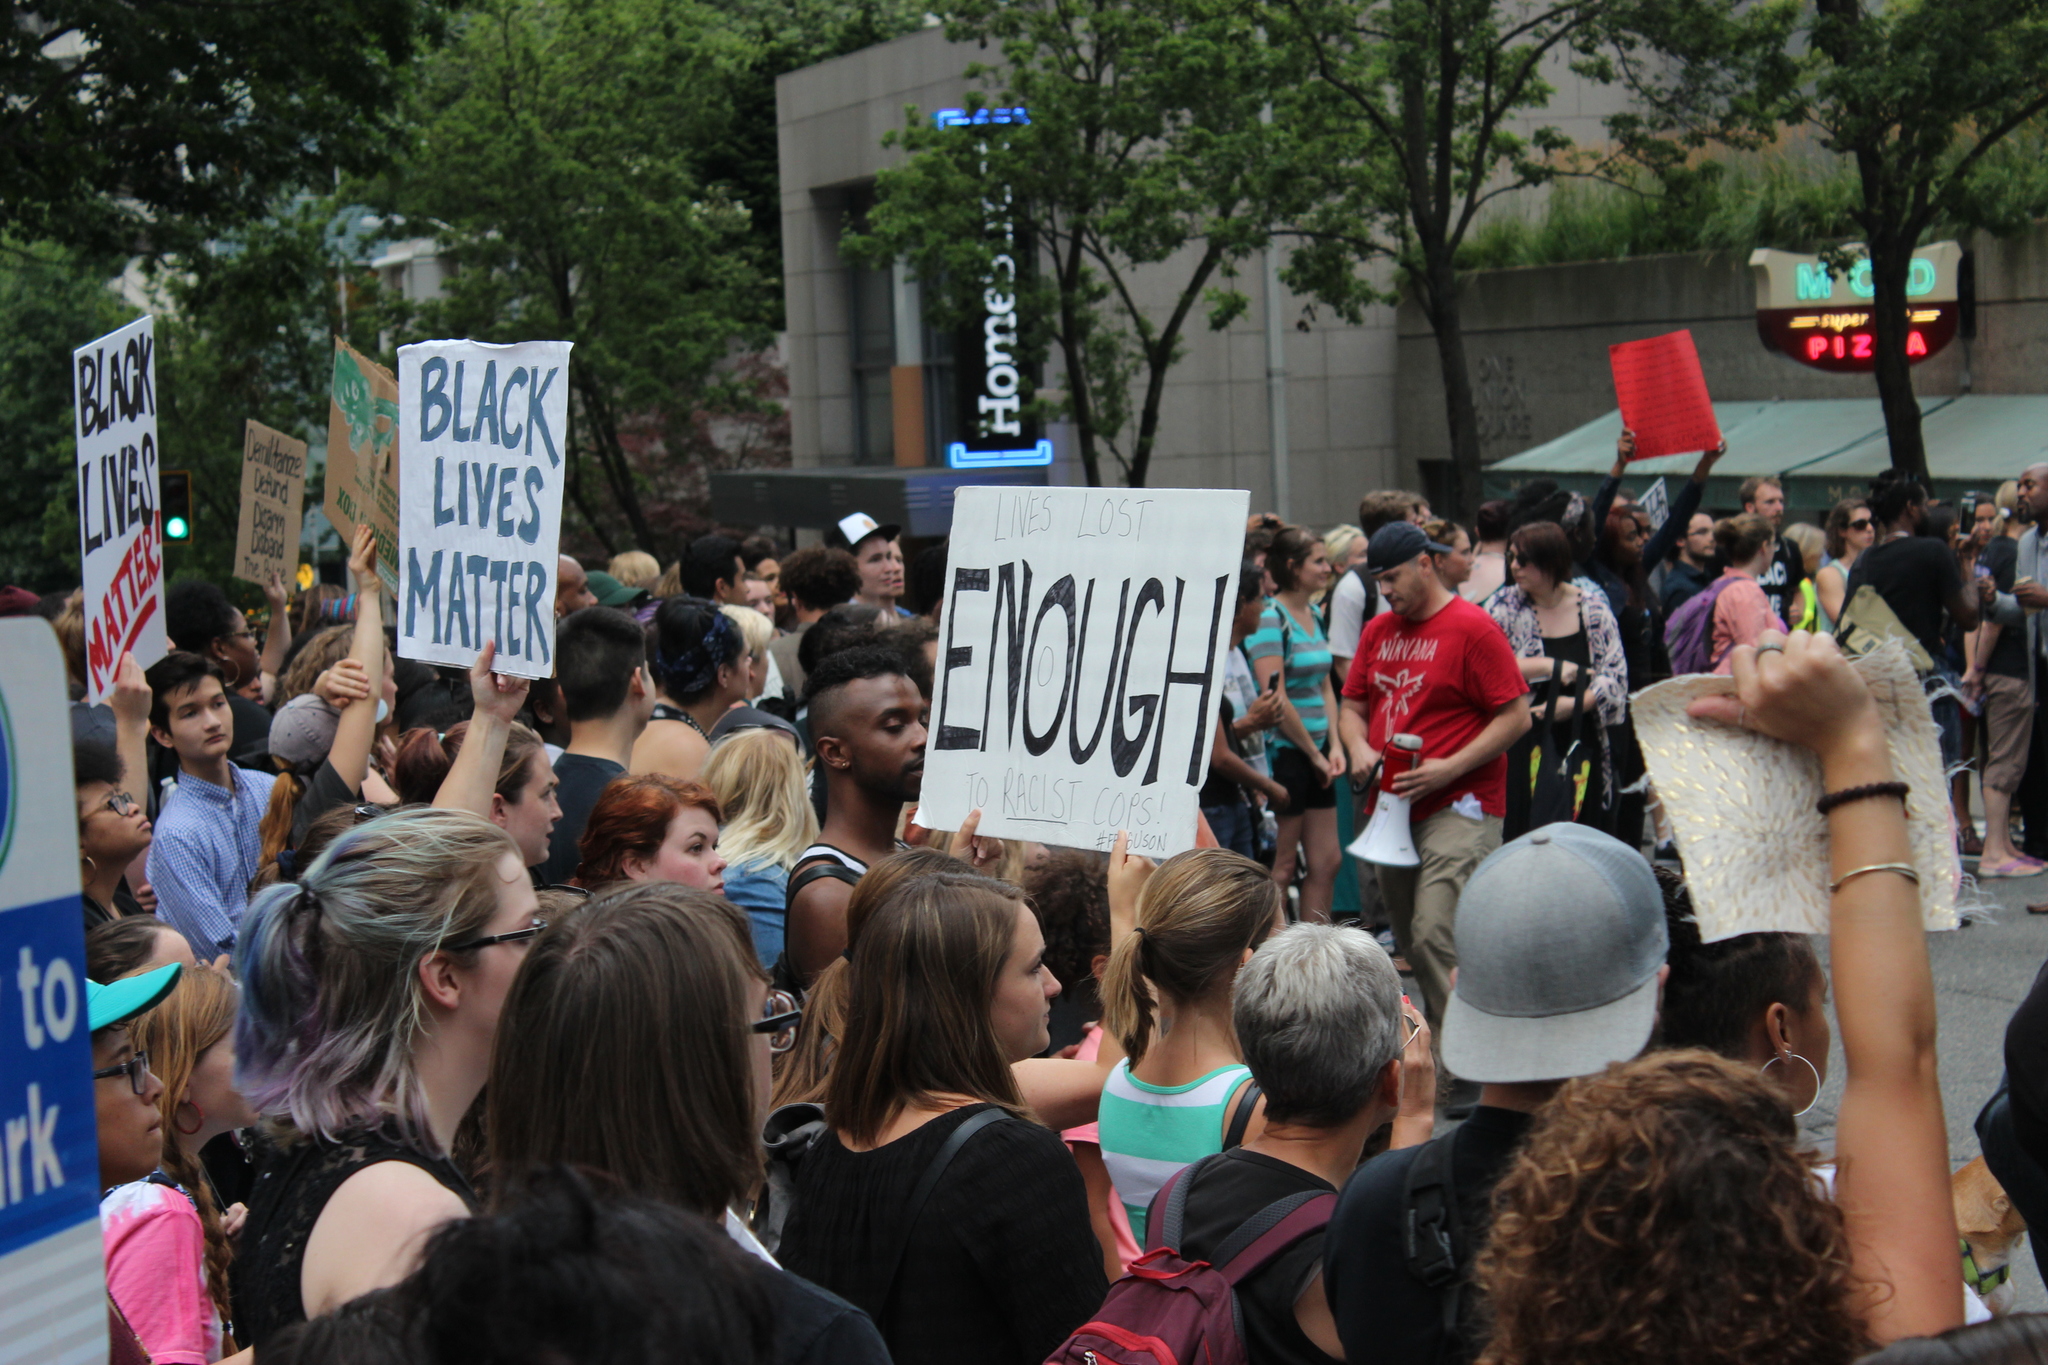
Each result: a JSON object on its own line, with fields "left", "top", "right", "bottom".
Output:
{"left": 397, "top": 342, "right": 569, "bottom": 677}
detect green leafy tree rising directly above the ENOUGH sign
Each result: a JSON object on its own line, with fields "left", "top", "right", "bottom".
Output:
{"left": 844, "top": 0, "right": 1305, "bottom": 487}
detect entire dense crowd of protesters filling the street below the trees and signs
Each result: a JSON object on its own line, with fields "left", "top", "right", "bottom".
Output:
{"left": 28, "top": 450, "right": 2048, "bottom": 1365}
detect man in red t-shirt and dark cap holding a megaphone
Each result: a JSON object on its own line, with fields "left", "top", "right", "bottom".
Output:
{"left": 1337, "top": 522, "right": 1530, "bottom": 1031}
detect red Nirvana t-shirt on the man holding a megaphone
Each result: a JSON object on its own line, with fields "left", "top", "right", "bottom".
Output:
{"left": 1343, "top": 598, "right": 1530, "bottom": 821}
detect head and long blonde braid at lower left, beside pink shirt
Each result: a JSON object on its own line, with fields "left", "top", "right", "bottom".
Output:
{"left": 126, "top": 966, "right": 256, "bottom": 1330}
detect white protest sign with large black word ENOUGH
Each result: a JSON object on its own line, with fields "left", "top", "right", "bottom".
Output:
{"left": 918, "top": 487, "right": 1251, "bottom": 857}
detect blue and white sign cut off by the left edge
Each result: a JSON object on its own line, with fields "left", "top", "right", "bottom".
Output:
{"left": 0, "top": 622, "right": 112, "bottom": 1365}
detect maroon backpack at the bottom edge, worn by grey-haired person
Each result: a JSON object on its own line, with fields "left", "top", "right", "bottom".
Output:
{"left": 1047, "top": 1154, "right": 1337, "bottom": 1365}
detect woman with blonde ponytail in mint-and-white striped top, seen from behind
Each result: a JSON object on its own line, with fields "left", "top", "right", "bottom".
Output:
{"left": 1098, "top": 849, "right": 1286, "bottom": 1246}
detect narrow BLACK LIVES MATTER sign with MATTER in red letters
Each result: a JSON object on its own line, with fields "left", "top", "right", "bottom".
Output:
{"left": 72, "top": 317, "right": 166, "bottom": 702}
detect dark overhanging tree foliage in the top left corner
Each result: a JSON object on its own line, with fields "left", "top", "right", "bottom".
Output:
{"left": 0, "top": 0, "right": 444, "bottom": 254}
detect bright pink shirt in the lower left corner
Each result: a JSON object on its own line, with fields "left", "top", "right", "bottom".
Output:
{"left": 100, "top": 1181, "right": 221, "bottom": 1365}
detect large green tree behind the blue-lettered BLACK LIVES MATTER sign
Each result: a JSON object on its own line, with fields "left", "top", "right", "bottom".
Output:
{"left": 377, "top": 0, "right": 778, "bottom": 553}
